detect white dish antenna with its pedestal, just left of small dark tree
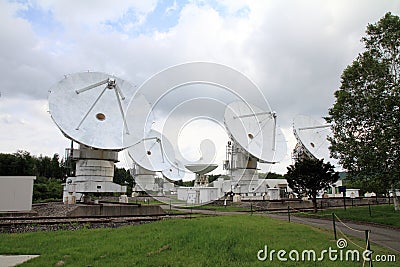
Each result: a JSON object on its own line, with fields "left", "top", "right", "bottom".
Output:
{"left": 224, "top": 102, "right": 286, "bottom": 195}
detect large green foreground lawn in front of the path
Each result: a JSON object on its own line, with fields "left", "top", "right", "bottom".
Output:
{"left": 0, "top": 215, "right": 400, "bottom": 267}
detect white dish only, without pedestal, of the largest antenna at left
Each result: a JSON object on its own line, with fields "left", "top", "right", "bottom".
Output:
{"left": 49, "top": 72, "right": 150, "bottom": 150}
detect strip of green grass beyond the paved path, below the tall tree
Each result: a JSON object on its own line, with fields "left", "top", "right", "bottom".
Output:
{"left": 309, "top": 205, "right": 400, "bottom": 227}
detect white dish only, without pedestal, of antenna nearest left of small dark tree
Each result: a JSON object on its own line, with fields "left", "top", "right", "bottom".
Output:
{"left": 224, "top": 101, "right": 286, "bottom": 163}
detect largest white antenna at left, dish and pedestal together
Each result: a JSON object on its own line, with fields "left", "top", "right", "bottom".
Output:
{"left": 49, "top": 72, "right": 150, "bottom": 203}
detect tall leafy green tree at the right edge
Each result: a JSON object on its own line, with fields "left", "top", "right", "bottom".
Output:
{"left": 326, "top": 13, "right": 400, "bottom": 210}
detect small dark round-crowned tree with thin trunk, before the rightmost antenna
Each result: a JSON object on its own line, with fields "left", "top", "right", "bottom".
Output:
{"left": 285, "top": 158, "right": 339, "bottom": 212}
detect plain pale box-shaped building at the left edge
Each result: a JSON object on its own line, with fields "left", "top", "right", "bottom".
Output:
{"left": 0, "top": 176, "right": 36, "bottom": 212}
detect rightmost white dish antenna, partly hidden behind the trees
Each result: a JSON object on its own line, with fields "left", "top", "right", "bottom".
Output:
{"left": 293, "top": 115, "right": 338, "bottom": 166}
